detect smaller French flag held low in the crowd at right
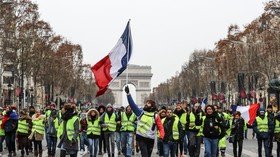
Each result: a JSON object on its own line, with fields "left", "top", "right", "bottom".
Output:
{"left": 231, "top": 103, "right": 260, "bottom": 125}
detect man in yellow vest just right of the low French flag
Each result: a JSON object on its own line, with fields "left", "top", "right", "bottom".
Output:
{"left": 253, "top": 108, "right": 273, "bottom": 157}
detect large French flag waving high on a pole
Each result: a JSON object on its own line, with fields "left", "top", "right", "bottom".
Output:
{"left": 91, "top": 21, "right": 132, "bottom": 97}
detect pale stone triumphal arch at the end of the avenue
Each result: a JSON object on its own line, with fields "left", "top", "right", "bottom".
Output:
{"left": 109, "top": 65, "right": 153, "bottom": 107}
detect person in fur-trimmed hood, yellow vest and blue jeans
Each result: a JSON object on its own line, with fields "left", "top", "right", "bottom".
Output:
{"left": 86, "top": 109, "right": 101, "bottom": 157}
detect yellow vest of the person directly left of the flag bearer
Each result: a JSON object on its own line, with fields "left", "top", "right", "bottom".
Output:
{"left": 121, "top": 112, "right": 136, "bottom": 132}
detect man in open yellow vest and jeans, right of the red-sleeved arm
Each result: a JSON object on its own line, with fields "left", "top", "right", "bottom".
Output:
{"left": 162, "top": 108, "right": 184, "bottom": 157}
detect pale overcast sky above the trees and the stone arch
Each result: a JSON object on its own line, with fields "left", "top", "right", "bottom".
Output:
{"left": 33, "top": 0, "right": 267, "bottom": 87}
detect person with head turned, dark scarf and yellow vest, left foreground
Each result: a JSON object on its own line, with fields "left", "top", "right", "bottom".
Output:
{"left": 57, "top": 103, "right": 79, "bottom": 157}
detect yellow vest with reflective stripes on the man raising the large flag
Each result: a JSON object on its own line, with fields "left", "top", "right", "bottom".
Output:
{"left": 137, "top": 111, "right": 155, "bottom": 136}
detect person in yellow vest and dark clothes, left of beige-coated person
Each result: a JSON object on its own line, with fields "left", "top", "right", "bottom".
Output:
{"left": 17, "top": 111, "right": 32, "bottom": 156}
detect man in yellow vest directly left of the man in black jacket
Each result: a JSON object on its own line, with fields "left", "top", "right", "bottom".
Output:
{"left": 186, "top": 103, "right": 203, "bottom": 157}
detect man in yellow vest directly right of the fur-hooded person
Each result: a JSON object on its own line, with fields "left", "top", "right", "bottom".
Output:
{"left": 100, "top": 104, "right": 118, "bottom": 157}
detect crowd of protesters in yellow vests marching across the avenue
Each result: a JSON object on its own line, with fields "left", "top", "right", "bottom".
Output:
{"left": 0, "top": 86, "right": 280, "bottom": 157}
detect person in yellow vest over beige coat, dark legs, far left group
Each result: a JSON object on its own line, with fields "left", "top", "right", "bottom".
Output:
{"left": 29, "top": 110, "right": 45, "bottom": 157}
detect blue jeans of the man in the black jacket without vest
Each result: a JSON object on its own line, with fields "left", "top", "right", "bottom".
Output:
{"left": 203, "top": 137, "right": 219, "bottom": 157}
